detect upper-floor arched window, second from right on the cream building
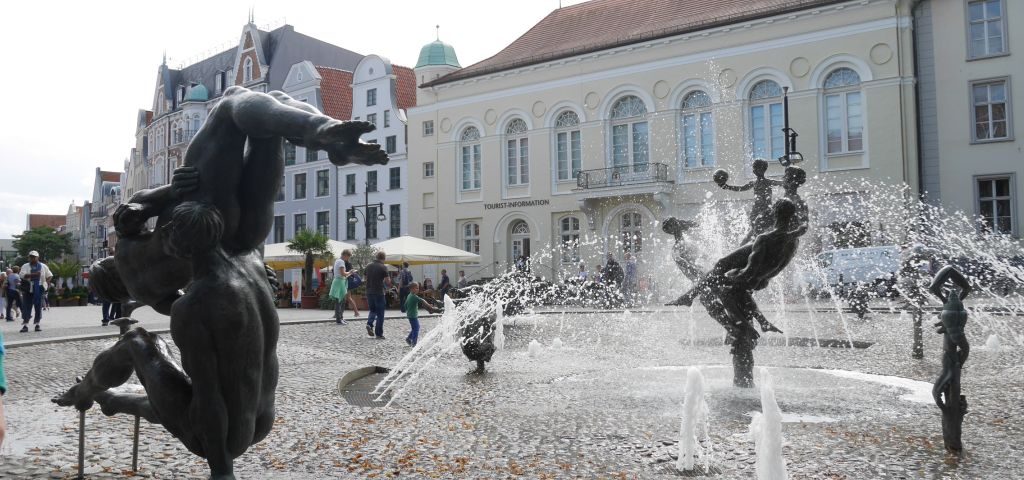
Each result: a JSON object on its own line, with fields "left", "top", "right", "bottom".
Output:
{"left": 750, "top": 80, "right": 785, "bottom": 159}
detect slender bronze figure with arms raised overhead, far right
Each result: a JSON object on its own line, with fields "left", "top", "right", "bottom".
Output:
{"left": 928, "top": 266, "right": 971, "bottom": 453}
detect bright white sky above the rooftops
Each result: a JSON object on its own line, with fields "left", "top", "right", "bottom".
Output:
{"left": 0, "top": 0, "right": 581, "bottom": 238}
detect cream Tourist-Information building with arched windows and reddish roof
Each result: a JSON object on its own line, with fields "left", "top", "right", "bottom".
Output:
{"left": 409, "top": 0, "right": 918, "bottom": 279}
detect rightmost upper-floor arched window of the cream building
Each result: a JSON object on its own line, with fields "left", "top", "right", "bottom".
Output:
{"left": 823, "top": 67, "right": 864, "bottom": 154}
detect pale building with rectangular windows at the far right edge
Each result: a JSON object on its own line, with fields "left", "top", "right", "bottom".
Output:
{"left": 913, "top": 0, "right": 1024, "bottom": 236}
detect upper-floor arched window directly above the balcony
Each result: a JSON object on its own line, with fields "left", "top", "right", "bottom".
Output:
{"left": 611, "top": 95, "right": 648, "bottom": 173}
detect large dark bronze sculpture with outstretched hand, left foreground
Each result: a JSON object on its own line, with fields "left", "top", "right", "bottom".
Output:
{"left": 53, "top": 87, "right": 387, "bottom": 479}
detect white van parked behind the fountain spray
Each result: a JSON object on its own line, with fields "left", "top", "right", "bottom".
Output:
{"left": 804, "top": 246, "right": 900, "bottom": 291}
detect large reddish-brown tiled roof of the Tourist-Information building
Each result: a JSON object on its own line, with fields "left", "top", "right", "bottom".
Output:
{"left": 426, "top": 0, "right": 848, "bottom": 85}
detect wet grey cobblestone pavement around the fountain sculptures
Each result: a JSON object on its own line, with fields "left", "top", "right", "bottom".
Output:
{"left": 0, "top": 307, "right": 1024, "bottom": 479}
